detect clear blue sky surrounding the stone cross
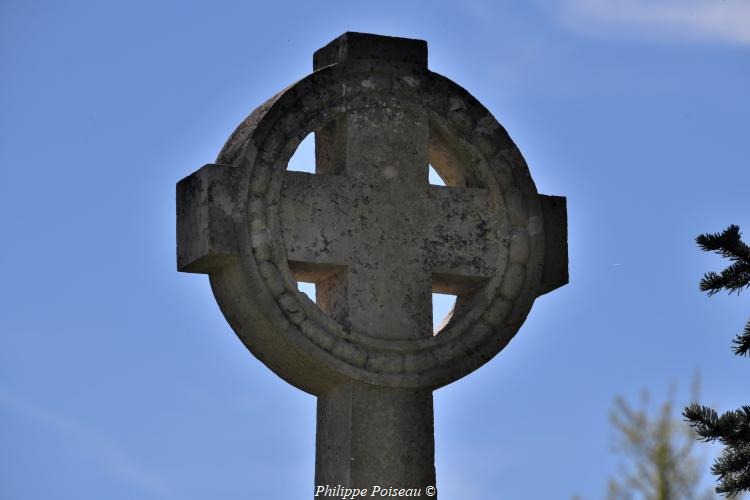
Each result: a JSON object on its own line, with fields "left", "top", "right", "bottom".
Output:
{"left": 0, "top": 0, "right": 750, "bottom": 500}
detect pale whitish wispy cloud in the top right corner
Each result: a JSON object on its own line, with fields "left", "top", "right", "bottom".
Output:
{"left": 560, "top": 0, "right": 750, "bottom": 45}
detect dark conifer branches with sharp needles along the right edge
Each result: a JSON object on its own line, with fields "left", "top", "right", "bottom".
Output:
{"left": 683, "top": 225, "right": 750, "bottom": 497}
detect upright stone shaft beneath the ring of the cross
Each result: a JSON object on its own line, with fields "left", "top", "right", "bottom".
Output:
{"left": 315, "top": 383, "right": 435, "bottom": 498}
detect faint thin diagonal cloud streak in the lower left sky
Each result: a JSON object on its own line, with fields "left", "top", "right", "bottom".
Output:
{"left": 0, "top": 389, "right": 174, "bottom": 498}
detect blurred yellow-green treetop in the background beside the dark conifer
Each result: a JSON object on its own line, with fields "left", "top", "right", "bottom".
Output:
{"left": 607, "top": 385, "right": 714, "bottom": 500}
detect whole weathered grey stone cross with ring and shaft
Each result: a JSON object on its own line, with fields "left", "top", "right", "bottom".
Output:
{"left": 177, "top": 33, "right": 567, "bottom": 498}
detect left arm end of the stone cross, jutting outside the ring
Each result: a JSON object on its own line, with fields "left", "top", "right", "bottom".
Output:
{"left": 177, "top": 164, "right": 238, "bottom": 274}
